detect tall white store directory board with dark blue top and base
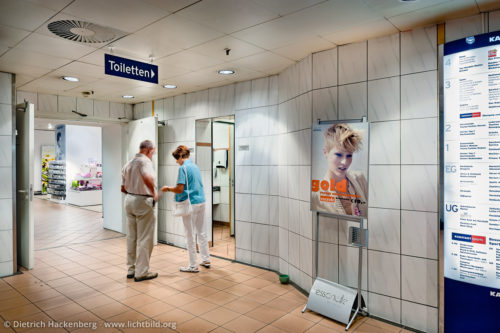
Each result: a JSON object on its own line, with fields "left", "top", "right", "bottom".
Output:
{"left": 443, "top": 32, "right": 500, "bottom": 332}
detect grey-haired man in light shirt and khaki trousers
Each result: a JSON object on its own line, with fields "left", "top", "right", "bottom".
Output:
{"left": 121, "top": 140, "right": 158, "bottom": 282}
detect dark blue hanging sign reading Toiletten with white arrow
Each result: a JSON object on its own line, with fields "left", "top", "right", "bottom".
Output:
{"left": 104, "top": 54, "right": 158, "bottom": 84}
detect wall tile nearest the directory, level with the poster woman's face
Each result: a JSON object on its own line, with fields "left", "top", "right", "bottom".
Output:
{"left": 401, "top": 118, "right": 438, "bottom": 164}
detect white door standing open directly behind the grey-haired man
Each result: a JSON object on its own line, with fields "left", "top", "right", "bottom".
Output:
{"left": 124, "top": 117, "right": 158, "bottom": 245}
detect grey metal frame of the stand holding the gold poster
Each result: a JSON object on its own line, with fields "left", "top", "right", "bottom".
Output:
{"left": 302, "top": 117, "right": 370, "bottom": 331}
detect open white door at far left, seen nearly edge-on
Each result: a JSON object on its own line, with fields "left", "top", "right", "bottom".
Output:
{"left": 16, "top": 103, "right": 35, "bottom": 269}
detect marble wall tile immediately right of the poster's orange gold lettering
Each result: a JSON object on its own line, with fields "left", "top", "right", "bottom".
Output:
{"left": 369, "top": 165, "right": 401, "bottom": 209}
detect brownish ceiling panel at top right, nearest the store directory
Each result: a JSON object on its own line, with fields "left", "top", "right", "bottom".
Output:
{"left": 388, "top": 0, "right": 479, "bottom": 31}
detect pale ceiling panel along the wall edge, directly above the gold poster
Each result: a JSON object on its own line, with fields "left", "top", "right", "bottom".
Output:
{"left": 322, "top": 19, "right": 399, "bottom": 45}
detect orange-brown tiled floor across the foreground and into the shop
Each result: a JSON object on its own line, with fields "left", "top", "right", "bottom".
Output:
{"left": 0, "top": 197, "right": 409, "bottom": 333}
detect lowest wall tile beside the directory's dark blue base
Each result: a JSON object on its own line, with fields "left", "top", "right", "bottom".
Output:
{"left": 401, "top": 301, "right": 439, "bottom": 333}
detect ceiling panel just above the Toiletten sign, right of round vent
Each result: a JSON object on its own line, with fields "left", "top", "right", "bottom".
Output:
{"left": 114, "top": 15, "right": 222, "bottom": 59}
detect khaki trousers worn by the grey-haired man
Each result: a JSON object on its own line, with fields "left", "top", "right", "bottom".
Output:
{"left": 125, "top": 194, "right": 155, "bottom": 278}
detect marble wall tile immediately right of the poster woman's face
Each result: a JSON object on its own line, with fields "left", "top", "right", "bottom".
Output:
{"left": 370, "top": 121, "right": 401, "bottom": 164}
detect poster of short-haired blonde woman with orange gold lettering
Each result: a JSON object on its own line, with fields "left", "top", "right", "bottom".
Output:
{"left": 311, "top": 122, "right": 369, "bottom": 218}
